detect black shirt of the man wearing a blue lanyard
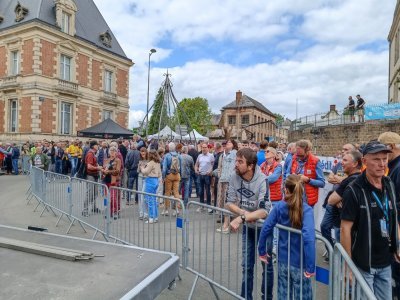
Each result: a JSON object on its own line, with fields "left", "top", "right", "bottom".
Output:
{"left": 341, "top": 172, "right": 392, "bottom": 268}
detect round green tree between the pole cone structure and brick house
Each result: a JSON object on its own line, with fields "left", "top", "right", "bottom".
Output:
{"left": 174, "top": 97, "right": 212, "bottom": 134}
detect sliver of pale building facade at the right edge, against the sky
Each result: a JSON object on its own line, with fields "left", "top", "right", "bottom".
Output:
{"left": 388, "top": 0, "right": 400, "bottom": 103}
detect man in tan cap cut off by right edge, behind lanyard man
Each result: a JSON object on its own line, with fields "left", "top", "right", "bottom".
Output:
{"left": 378, "top": 132, "right": 400, "bottom": 299}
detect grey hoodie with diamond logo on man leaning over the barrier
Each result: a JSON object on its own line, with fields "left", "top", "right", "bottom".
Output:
{"left": 226, "top": 166, "right": 271, "bottom": 227}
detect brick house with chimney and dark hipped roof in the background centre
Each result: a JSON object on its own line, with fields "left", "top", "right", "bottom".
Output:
{"left": 220, "top": 91, "right": 278, "bottom": 142}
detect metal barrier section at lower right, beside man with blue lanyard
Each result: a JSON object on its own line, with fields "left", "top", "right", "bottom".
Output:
{"left": 332, "top": 243, "right": 376, "bottom": 300}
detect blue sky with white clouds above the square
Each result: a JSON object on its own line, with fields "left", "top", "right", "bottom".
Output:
{"left": 94, "top": 0, "right": 396, "bottom": 127}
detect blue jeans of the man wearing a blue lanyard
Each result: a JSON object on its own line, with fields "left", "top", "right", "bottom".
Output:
{"left": 358, "top": 266, "right": 392, "bottom": 300}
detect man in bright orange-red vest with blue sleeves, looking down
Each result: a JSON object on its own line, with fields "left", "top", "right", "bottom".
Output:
{"left": 285, "top": 140, "right": 325, "bottom": 207}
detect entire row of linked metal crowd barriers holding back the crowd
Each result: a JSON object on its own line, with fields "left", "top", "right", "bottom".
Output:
{"left": 28, "top": 167, "right": 375, "bottom": 299}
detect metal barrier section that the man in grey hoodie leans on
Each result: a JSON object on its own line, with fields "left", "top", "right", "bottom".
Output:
{"left": 186, "top": 201, "right": 333, "bottom": 299}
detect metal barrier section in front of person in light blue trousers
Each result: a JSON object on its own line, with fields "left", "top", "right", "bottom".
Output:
{"left": 109, "top": 186, "right": 186, "bottom": 266}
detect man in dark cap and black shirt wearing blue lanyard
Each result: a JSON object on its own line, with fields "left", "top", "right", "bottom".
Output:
{"left": 340, "top": 141, "right": 399, "bottom": 300}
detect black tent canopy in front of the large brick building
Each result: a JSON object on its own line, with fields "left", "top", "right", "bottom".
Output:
{"left": 78, "top": 119, "right": 133, "bottom": 139}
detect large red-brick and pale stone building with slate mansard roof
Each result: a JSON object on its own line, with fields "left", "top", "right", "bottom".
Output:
{"left": 0, "top": 0, "right": 133, "bottom": 140}
